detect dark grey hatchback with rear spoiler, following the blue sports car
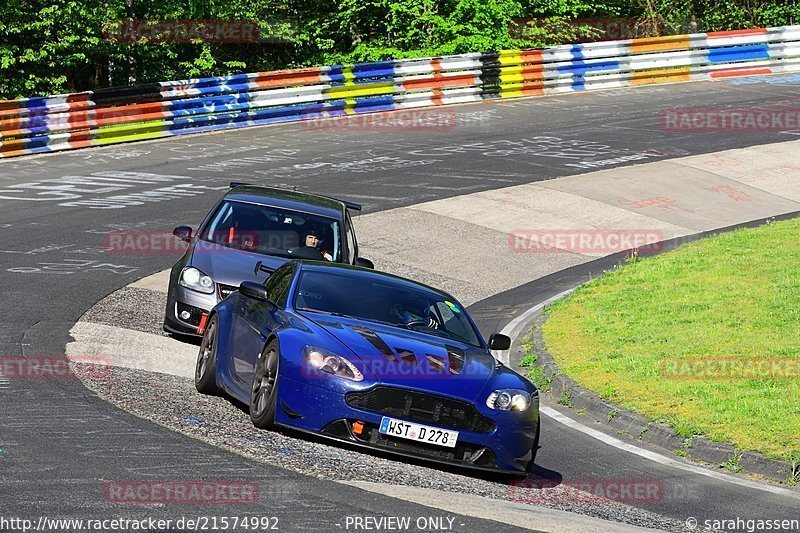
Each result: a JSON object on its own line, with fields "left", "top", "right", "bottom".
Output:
{"left": 164, "top": 182, "right": 372, "bottom": 335}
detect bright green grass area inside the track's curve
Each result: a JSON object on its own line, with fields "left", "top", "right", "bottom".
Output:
{"left": 543, "top": 219, "right": 800, "bottom": 460}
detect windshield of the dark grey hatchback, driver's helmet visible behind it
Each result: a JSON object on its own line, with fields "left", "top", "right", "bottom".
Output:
{"left": 200, "top": 200, "right": 342, "bottom": 261}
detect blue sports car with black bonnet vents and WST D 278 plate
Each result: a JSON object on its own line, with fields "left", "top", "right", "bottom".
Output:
{"left": 195, "top": 260, "right": 539, "bottom": 475}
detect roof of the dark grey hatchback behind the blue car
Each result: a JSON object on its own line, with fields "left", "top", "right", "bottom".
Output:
{"left": 224, "top": 185, "right": 346, "bottom": 219}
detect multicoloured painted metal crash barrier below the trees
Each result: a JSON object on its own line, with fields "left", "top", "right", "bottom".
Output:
{"left": 0, "top": 26, "right": 800, "bottom": 157}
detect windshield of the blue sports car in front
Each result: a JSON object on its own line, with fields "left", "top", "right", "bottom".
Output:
{"left": 294, "top": 269, "right": 481, "bottom": 348}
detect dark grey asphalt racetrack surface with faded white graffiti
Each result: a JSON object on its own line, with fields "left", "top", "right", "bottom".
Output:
{"left": 0, "top": 76, "right": 800, "bottom": 531}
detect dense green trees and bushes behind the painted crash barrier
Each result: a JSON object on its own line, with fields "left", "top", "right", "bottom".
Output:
{"left": 0, "top": 0, "right": 800, "bottom": 98}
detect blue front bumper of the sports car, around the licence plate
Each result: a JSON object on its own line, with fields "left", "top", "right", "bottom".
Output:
{"left": 276, "top": 376, "right": 539, "bottom": 474}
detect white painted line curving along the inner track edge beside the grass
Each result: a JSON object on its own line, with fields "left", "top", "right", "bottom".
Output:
{"left": 501, "top": 296, "right": 800, "bottom": 499}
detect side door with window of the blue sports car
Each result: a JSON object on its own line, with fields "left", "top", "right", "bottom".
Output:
{"left": 233, "top": 265, "right": 294, "bottom": 387}
